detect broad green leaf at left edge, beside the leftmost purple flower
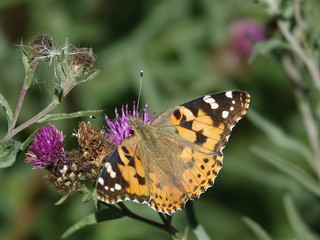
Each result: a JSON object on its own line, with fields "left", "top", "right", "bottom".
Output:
{"left": 0, "top": 140, "right": 21, "bottom": 168}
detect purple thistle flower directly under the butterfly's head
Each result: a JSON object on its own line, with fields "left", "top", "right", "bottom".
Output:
{"left": 105, "top": 103, "right": 156, "bottom": 146}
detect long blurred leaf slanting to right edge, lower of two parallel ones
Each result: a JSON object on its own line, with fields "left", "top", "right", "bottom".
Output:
{"left": 252, "top": 147, "right": 320, "bottom": 196}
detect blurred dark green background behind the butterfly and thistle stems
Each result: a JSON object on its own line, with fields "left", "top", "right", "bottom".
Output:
{"left": 0, "top": 0, "right": 320, "bottom": 240}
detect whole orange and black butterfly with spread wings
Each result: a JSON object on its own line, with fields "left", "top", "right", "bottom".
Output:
{"left": 97, "top": 91, "right": 250, "bottom": 214}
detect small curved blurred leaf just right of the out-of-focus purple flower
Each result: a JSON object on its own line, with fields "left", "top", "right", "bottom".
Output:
{"left": 248, "top": 38, "right": 290, "bottom": 63}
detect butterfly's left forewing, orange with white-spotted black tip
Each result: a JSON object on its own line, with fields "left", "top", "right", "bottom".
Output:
{"left": 97, "top": 139, "right": 150, "bottom": 203}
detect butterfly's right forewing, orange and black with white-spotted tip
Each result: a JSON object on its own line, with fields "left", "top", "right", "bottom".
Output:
{"left": 160, "top": 91, "right": 250, "bottom": 153}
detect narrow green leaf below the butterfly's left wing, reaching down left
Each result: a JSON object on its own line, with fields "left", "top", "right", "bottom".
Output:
{"left": 62, "top": 207, "right": 124, "bottom": 238}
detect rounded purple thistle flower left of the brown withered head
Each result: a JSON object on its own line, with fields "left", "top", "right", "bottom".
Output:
{"left": 26, "top": 125, "right": 67, "bottom": 168}
